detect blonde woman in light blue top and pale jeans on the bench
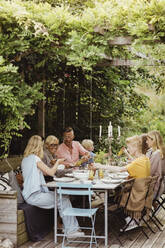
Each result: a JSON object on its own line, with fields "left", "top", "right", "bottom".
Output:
{"left": 21, "top": 135, "right": 84, "bottom": 237}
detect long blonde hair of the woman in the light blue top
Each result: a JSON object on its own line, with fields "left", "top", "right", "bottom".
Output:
{"left": 23, "top": 135, "right": 43, "bottom": 159}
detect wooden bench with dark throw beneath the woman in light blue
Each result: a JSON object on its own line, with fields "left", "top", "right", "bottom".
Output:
{"left": 0, "top": 157, "right": 54, "bottom": 247}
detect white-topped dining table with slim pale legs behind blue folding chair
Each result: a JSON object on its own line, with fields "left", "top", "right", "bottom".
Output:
{"left": 46, "top": 176, "right": 125, "bottom": 247}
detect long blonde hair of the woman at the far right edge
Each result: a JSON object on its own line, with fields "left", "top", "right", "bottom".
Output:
{"left": 147, "top": 130, "right": 165, "bottom": 159}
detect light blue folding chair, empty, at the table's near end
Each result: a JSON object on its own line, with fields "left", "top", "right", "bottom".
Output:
{"left": 57, "top": 183, "right": 98, "bottom": 248}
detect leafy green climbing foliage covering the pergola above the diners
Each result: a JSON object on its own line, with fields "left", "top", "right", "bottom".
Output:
{"left": 0, "top": 0, "right": 165, "bottom": 156}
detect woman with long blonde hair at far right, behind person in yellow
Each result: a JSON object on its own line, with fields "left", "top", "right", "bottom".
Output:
{"left": 147, "top": 130, "right": 165, "bottom": 198}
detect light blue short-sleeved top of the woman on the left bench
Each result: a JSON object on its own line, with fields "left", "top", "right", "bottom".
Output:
{"left": 21, "top": 154, "right": 49, "bottom": 200}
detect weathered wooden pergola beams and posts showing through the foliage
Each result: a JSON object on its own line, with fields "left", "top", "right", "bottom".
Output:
{"left": 38, "top": 34, "right": 165, "bottom": 139}
